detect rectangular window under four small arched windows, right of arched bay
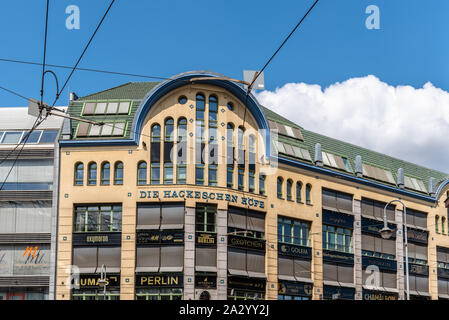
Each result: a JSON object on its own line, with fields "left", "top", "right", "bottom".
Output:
{"left": 278, "top": 217, "right": 310, "bottom": 247}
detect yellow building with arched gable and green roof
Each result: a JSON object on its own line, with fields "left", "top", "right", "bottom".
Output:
{"left": 56, "top": 72, "right": 449, "bottom": 300}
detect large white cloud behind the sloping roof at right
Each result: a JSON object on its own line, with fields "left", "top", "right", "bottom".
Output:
{"left": 256, "top": 75, "right": 449, "bottom": 172}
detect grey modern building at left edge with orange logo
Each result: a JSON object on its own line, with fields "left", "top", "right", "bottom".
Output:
{"left": 0, "top": 107, "right": 62, "bottom": 300}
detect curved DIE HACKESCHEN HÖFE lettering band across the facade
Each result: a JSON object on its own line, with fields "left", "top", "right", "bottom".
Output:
{"left": 139, "top": 190, "right": 265, "bottom": 209}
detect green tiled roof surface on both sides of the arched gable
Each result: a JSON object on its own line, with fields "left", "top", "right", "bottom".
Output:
{"left": 64, "top": 82, "right": 449, "bottom": 192}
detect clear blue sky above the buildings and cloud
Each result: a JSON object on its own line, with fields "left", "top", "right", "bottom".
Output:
{"left": 0, "top": 0, "right": 449, "bottom": 106}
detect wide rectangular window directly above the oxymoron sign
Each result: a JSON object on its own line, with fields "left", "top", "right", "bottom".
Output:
{"left": 74, "top": 205, "right": 122, "bottom": 232}
